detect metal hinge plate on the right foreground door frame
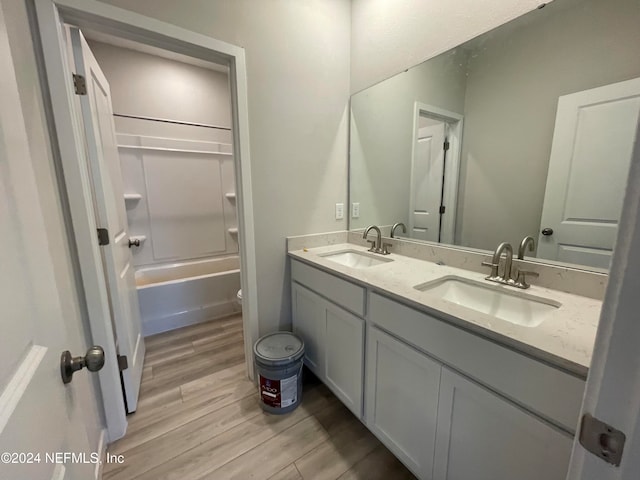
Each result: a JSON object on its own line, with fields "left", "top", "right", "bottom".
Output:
{"left": 579, "top": 413, "right": 626, "bottom": 467}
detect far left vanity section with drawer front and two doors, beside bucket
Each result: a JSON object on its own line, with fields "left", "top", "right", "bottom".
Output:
{"left": 291, "top": 262, "right": 364, "bottom": 418}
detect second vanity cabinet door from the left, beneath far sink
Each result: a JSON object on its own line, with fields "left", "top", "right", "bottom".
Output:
{"left": 324, "top": 302, "right": 364, "bottom": 417}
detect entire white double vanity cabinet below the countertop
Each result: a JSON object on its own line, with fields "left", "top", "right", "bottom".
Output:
{"left": 291, "top": 260, "right": 585, "bottom": 480}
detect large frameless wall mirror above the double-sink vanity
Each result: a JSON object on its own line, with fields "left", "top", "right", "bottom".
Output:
{"left": 349, "top": 0, "right": 640, "bottom": 270}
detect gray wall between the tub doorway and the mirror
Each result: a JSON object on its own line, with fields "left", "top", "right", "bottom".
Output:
{"left": 97, "top": 0, "right": 351, "bottom": 333}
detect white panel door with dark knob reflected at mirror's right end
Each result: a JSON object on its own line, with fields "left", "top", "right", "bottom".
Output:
{"left": 538, "top": 78, "right": 640, "bottom": 268}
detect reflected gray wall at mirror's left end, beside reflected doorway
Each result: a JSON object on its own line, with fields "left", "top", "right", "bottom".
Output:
{"left": 349, "top": 49, "right": 467, "bottom": 228}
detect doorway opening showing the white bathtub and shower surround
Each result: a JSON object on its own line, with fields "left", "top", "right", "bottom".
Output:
{"left": 82, "top": 30, "right": 240, "bottom": 337}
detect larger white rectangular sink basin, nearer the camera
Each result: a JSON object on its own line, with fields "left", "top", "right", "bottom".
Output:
{"left": 413, "top": 276, "right": 560, "bottom": 327}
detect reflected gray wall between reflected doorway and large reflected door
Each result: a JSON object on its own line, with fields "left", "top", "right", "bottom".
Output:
{"left": 456, "top": 0, "right": 640, "bottom": 250}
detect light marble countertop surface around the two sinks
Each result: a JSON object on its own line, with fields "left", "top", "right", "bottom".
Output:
{"left": 289, "top": 243, "right": 602, "bottom": 378}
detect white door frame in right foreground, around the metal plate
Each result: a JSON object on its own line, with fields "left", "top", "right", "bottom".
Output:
{"left": 567, "top": 122, "right": 640, "bottom": 480}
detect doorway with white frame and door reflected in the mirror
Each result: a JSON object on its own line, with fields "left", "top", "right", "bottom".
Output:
{"left": 408, "top": 102, "right": 463, "bottom": 244}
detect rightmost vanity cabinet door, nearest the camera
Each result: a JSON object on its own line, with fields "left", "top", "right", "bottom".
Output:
{"left": 434, "top": 368, "right": 573, "bottom": 480}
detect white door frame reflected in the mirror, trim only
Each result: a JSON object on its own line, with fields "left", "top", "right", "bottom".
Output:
{"left": 409, "top": 101, "right": 464, "bottom": 244}
